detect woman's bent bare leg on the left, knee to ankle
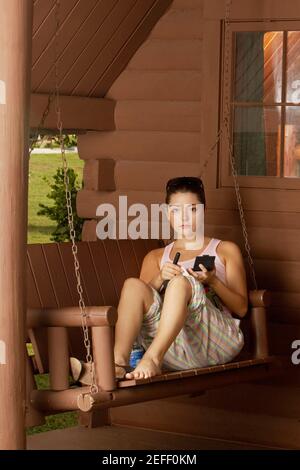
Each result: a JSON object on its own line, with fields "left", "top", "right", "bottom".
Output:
{"left": 114, "top": 277, "right": 154, "bottom": 365}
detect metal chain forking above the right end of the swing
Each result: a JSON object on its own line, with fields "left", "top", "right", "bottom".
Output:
{"left": 200, "top": 0, "right": 258, "bottom": 290}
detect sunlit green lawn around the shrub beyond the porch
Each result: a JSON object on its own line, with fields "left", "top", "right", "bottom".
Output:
{"left": 28, "top": 153, "right": 83, "bottom": 243}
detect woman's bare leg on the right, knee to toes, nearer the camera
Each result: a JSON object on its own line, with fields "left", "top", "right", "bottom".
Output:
{"left": 126, "top": 275, "right": 192, "bottom": 379}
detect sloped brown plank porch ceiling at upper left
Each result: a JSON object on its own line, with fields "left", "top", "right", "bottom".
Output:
{"left": 32, "top": 0, "right": 172, "bottom": 97}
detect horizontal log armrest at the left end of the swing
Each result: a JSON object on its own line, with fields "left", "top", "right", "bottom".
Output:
{"left": 27, "top": 306, "right": 118, "bottom": 328}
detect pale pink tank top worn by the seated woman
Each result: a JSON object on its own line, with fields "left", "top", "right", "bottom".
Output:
{"left": 160, "top": 238, "right": 240, "bottom": 325}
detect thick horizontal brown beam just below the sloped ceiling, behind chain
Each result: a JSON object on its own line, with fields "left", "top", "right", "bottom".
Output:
{"left": 30, "top": 93, "right": 115, "bottom": 131}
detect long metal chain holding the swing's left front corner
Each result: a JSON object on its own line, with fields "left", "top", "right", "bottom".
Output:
{"left": 54, "top": 0, "right": 98, "bottom": 393}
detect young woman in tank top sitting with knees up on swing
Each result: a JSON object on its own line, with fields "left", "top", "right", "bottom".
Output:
{"left": 71, "top": 177, "right": 248, "bottom": 383}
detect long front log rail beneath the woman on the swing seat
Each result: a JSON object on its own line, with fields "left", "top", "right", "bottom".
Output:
{"left": 31, "top": 357, "right": 283, "bottom": 412}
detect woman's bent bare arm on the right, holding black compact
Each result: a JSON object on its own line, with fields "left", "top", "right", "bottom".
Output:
{"left": 209, "top": 242, "right": 248, "bottom": 318}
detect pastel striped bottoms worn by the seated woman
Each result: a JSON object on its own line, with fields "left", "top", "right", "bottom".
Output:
{"left": 137, "top": 274, "right": 244, "bottom": 370}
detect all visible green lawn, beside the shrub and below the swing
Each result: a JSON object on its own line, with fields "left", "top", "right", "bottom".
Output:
{"left": 27, "top": 153, "right": 83, "bottom": 434}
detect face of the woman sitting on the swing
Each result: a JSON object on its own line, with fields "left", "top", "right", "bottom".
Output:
{"left": 168, "top": 192, "right": 204, "bottom": 240}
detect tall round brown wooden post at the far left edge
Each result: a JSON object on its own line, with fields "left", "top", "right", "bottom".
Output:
{"left": 0, "top": 0, "right": 33, "bottom": 450}
